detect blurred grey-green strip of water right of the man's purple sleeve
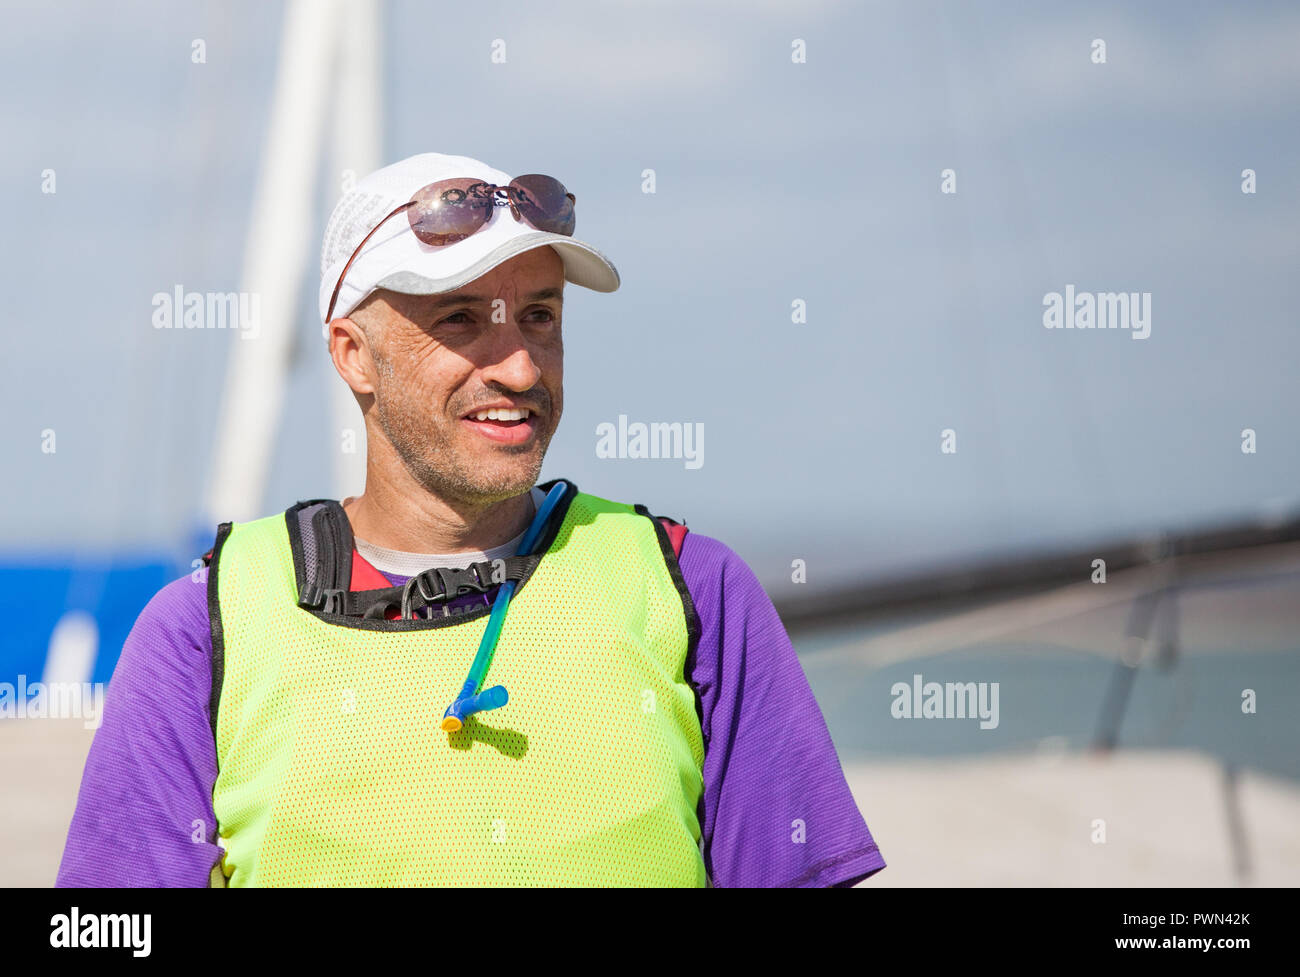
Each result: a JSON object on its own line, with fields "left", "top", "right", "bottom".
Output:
{"left": 794, "top": 628, "right": 1300, "bottom": 781}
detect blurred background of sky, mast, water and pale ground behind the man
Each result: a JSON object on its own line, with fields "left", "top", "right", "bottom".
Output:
{"left": 0, "top": 0, "right": 1300, "bottom": 886}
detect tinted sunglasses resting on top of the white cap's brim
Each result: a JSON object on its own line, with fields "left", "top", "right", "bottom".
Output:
{"left": 325, "top": 173, "right": 577, "bottom": 324}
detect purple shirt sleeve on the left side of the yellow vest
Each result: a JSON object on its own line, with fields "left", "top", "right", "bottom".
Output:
{"left": 55, "top": 568, "right": 221, "bottom": 887}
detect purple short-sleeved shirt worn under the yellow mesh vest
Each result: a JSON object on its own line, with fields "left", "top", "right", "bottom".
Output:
{"left": 56, "top": 533, "right": 885, "bottom": 887}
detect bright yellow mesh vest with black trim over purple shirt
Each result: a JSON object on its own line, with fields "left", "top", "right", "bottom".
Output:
{"left": 209, "top": 489, "right": 706, "bottom": 886}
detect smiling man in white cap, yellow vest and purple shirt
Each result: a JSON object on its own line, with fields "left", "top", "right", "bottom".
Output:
{"left": 50, "top": 153, "right": 884, "bottom": 886}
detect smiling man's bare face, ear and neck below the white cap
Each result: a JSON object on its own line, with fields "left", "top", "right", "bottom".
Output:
{"left": 330, "top": 247, "right": 564, "bottom": 553}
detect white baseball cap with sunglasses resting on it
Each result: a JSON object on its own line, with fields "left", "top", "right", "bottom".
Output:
{"left": 320, "top": 153, "right": 619, "bottom": 320}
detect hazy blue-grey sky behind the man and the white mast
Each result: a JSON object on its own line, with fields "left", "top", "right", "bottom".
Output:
{"left": 0, "top": 0, "right": 1300, "bottom": 587}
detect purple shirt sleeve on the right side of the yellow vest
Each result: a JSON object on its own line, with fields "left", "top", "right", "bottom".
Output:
{"left": 680, "top": 533, "right": 885, "bottom": 887}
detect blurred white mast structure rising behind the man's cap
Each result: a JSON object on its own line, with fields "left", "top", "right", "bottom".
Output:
{"left": 205, "top": 0, "right": 381, "bottom": 525}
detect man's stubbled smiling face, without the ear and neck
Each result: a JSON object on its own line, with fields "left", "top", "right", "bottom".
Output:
{"left": 352, "top": 247, "right": 564, "bottom": 504}
